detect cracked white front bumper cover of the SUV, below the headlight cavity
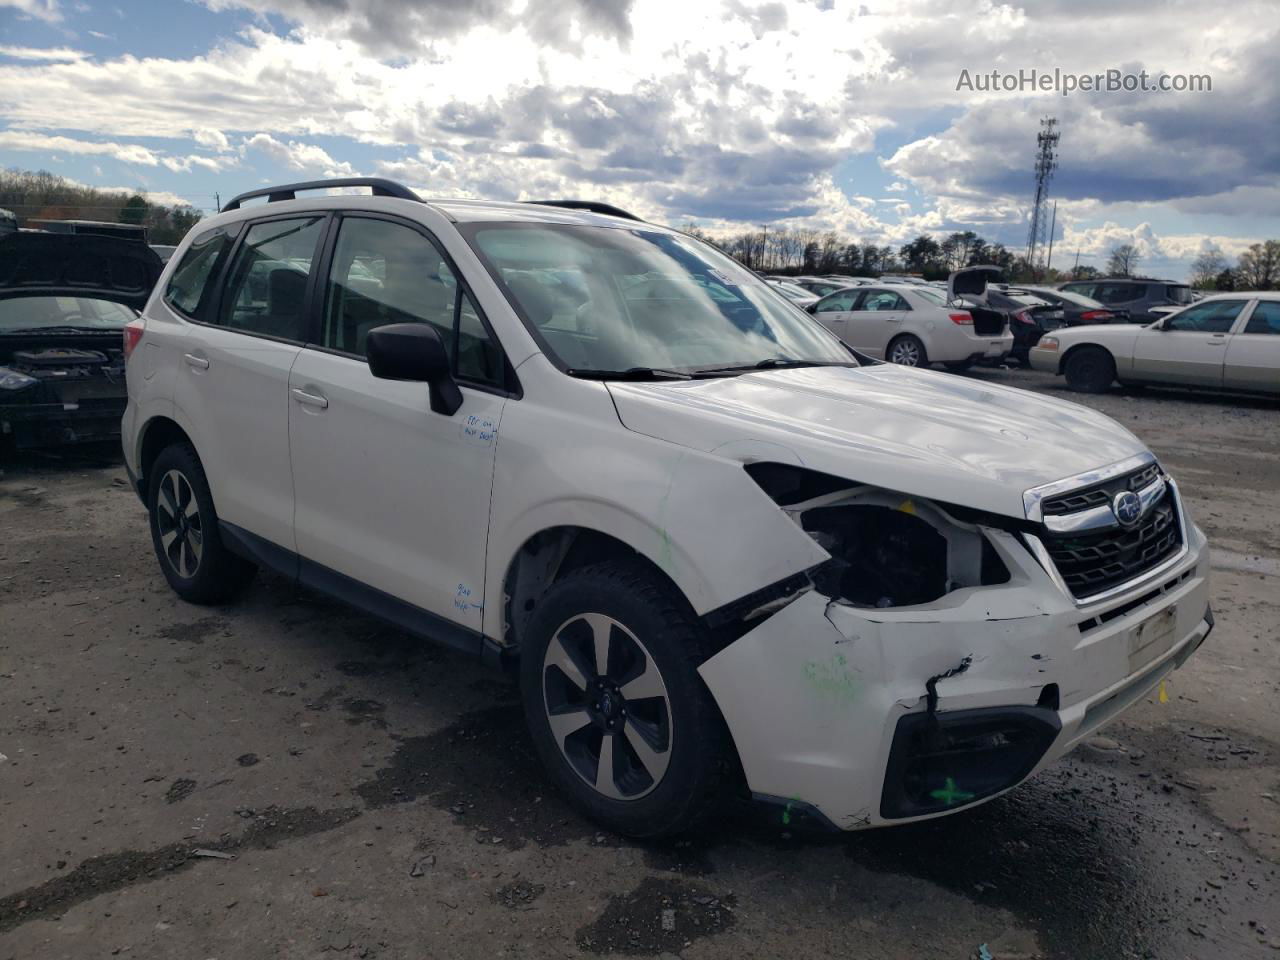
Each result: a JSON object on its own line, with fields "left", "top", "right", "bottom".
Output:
{"left": 699, "top": 525, "right": 1213, "bottom": 829}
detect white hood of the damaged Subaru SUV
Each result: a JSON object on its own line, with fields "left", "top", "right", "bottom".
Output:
{"left": 608, "top": 364, "right": 1146, "bottom": 518}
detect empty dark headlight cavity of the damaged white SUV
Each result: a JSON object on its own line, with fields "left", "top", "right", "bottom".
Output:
{"left": 746, "top": 463, "right": 1009, "bottom": 607}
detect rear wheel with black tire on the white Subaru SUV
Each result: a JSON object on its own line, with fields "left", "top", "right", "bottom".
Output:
{"left": 147, "top": 443, "right": 257, "bottom": 604}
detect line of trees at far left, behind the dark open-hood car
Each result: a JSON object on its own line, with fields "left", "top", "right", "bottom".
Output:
{"left": 0, "top": 169, "right": 205, "bottom": 244}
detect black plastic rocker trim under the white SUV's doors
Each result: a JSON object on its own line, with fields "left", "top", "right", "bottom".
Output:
{"left": 218, "top": 521, "right": 483, "bottom": 664}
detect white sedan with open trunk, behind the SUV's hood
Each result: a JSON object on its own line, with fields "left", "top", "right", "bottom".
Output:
{"left": 805, "top": 268, "right": 1014, "bottom": 370}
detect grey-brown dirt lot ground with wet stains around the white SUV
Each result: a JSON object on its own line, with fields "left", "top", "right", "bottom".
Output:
{"left": 0, "top": 371, "right": 1280, "bottom": 960}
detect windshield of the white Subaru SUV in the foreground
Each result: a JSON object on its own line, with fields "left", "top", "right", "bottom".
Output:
{"left": 463, "top": 223, "right": 855, "bottom": 374}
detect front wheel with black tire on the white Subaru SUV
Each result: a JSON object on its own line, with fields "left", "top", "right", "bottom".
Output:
{"left": 520, "top": 562, "right": 731, "bottom": 837}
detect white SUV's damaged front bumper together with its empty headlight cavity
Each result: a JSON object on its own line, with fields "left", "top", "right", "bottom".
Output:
{"left": 700, "top": 465, "right": 1212, "bottom": 829}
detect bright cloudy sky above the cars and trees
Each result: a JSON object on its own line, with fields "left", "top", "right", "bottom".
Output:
{"left": 0, "top": 0, "right": 1280, "bottom": 276}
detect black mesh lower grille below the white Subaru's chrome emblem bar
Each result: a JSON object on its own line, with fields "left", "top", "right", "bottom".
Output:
{"left": 1044, "top": 491, "right": 1183, "bottom": 599}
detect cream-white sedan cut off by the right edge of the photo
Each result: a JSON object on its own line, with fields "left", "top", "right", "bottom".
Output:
{"left": 1030, "top": 291, "right": 1280, "bottom": 393}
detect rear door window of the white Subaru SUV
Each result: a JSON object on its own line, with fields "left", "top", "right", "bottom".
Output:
{"left": 216, "top": 216, "right": 325, "bottom": 342}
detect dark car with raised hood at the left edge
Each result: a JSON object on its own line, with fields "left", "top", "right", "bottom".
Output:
{"left": 0, "top": 233, "right": 161, "bottom": 449}
